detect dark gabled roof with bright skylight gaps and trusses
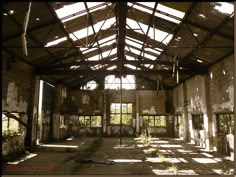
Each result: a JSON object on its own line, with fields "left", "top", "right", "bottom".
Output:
{"left": 2, "top": 2, "right": 234, "bottom": 89}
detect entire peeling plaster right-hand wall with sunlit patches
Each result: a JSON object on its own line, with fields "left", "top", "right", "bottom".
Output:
{"left": 173, "top": 55, "right": 234, "bottom": 152}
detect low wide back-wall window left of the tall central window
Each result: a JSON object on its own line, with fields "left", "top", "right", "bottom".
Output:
{"left": 79, "top": 116, "right": 102, "bottom": 127}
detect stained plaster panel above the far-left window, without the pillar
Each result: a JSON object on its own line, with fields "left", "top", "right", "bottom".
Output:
{"left": 2, "top": 52, "right": 33, "bottom": 112}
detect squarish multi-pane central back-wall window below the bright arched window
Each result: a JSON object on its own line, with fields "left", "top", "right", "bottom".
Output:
{"left": 110, "top": 103, "right": 133, "bottom": 125}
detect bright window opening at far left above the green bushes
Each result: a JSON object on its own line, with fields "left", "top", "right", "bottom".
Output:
{"left": 2, "top": 113, "right": 19, "bottom": 132}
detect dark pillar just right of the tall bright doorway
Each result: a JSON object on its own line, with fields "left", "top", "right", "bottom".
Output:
{"left": 52, "top": 84, "right": 62, "bottom": 140}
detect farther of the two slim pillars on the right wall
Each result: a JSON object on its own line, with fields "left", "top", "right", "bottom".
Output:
{"left": 183, "top": 82, "right": 190, "bottom": 142}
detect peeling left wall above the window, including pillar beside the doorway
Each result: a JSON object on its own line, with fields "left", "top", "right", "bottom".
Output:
{"left": 2, "top": 52, "right": 37, "bottom": 146}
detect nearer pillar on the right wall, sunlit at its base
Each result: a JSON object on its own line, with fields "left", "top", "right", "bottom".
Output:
{"left": 204, "top": 75, "right": 214, "bottom": 150}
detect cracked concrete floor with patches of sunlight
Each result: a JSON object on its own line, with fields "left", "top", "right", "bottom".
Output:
{"left": 3, "top": 138, "right": 234, "bottom": 175}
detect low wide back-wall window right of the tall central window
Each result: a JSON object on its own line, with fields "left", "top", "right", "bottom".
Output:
{"left": 143, "top": 115, "right": 166, "bottom": 127}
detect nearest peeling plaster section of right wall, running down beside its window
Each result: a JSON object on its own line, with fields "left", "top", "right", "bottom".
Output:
{"left": 209, "top": 55, "right": 234, "bottom": 152}
